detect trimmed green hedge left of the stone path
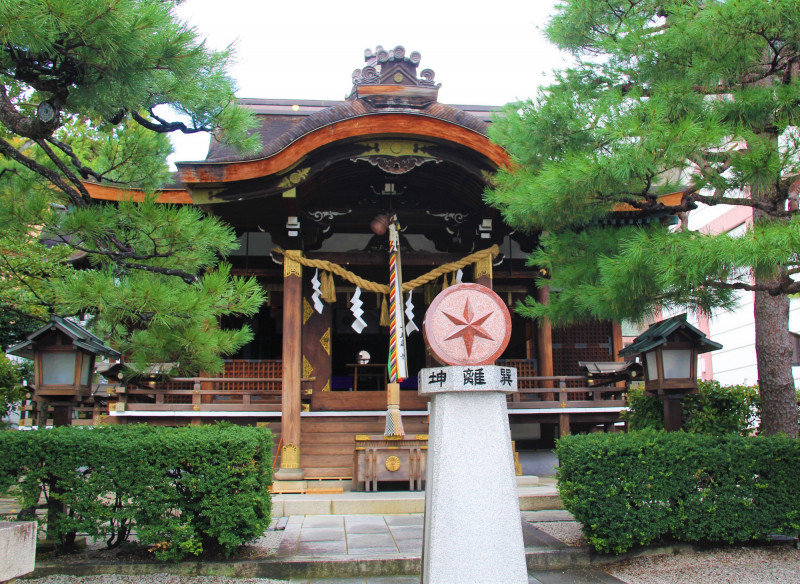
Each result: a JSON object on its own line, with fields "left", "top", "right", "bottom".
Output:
{"left": 0, "top": 424, "right": 272, "bottom": 560}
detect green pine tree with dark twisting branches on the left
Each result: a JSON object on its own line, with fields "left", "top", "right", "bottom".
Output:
{"left": 0, "top": 0, "right": 265, "bottom": 373}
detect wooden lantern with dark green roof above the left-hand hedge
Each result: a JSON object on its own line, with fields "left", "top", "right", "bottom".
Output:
{"left": 8, "top": 315, "right": 120, "bottom": 428}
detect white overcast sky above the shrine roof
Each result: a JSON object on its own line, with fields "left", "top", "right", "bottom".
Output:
{"left": 171, "top": 0, "right": 565, "bottom": 160}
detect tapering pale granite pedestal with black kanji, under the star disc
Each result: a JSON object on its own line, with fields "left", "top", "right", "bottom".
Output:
{"left": 419, "top": 365, "right": 528, "bottom": 584}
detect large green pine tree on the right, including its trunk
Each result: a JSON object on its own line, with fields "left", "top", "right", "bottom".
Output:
{"left": 488, "top": 0, "right": 800, "bottom": 436}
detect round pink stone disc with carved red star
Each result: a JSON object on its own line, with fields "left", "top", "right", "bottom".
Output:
{"left": 422, "top": 284, "right": 511, "bottom": 365}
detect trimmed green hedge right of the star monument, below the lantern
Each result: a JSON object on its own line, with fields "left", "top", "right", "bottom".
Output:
{"left": 556, "top": 431, "right": 800, "bottom": 553}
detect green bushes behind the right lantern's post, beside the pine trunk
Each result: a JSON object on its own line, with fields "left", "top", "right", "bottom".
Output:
{"left": 623, "top": 380, "right": 760, "bottom": 435}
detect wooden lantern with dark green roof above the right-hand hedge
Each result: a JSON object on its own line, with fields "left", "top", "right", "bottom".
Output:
{"left": 619, "top": 314, "right": 722, "bottom": 431}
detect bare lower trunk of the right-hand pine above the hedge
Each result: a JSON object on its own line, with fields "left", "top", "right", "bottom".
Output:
{"left": 753, "top": 292, "right": 798, "bottom": 438}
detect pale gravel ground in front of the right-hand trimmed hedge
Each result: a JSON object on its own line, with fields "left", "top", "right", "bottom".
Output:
{"left": 602, "top": 545, "right": 800, "bottom": 584}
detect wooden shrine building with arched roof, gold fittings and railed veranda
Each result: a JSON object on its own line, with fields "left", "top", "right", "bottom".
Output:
{"left": 21, "top": 47, "right": 640, "bottom": 490}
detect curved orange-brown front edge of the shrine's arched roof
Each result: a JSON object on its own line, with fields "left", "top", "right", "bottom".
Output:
{"left": 176, "top": 112, "right": 511, "bottom": 186}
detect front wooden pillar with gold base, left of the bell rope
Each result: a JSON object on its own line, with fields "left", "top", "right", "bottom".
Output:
{"left": 275, "top": 251, "right": 303, "bottom": 481}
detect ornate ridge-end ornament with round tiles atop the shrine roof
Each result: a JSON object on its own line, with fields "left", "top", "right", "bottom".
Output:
{"left": 348, "top": 45, "right": 441, "bottom": 108}
